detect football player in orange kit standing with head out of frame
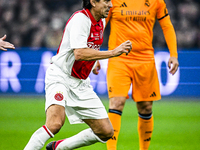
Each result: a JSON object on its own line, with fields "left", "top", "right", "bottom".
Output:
{"left": 106, "top": 0, "right": 179, "bottom": 150}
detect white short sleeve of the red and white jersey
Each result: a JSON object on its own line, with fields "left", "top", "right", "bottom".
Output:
{"left": 69, "top": 13, "right": 91, "bottom": 49}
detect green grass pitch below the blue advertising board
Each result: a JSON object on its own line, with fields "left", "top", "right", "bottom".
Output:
{"left": 0, "top": 97, "right": 200, "bottom": 150}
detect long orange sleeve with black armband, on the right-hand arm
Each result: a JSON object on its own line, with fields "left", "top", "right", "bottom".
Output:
{"left": 157, "top": 0, "right": 178, "bottom": 58}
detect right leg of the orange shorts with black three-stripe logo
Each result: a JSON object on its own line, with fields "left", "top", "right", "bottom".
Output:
{"left": 132, "top": 62, "right": 161, "bottom": 102}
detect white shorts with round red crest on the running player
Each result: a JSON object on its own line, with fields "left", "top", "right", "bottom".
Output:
{"left": 45, "top": 64, "right": 108, "bottom": 124}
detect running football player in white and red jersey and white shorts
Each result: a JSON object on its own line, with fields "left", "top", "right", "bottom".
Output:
{"left": 24, "top": 0, "right": 132, "bottom": 150}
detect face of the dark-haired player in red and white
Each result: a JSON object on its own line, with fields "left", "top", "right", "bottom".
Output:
{"left": 94, "top": 0, "right": 112, "bottom": 18}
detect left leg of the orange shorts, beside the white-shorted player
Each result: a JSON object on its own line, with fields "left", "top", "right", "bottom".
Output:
{"left": 107, "top": 60, "right": 131, "bottom": 98}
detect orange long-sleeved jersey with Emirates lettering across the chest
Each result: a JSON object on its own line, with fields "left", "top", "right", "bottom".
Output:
{"left": 106, "top": 0, "right": 177, "bottom": 61}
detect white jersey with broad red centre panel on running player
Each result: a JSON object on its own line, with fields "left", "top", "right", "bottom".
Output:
{"left": 51, "top": 9, "right": 105, "bottom": 79}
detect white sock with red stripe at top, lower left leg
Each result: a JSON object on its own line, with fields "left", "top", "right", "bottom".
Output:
{"left": 24, "top": 126, "right": 54, "bottom": 150}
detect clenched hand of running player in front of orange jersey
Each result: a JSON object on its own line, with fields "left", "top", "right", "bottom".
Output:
{"left": 113, "top": 40, "right": 132, "bottom": 56}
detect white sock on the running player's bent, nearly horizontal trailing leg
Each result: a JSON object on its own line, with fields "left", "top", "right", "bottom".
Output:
{"left": 56, "top": 128, "right": 106, "bottom": 150}
